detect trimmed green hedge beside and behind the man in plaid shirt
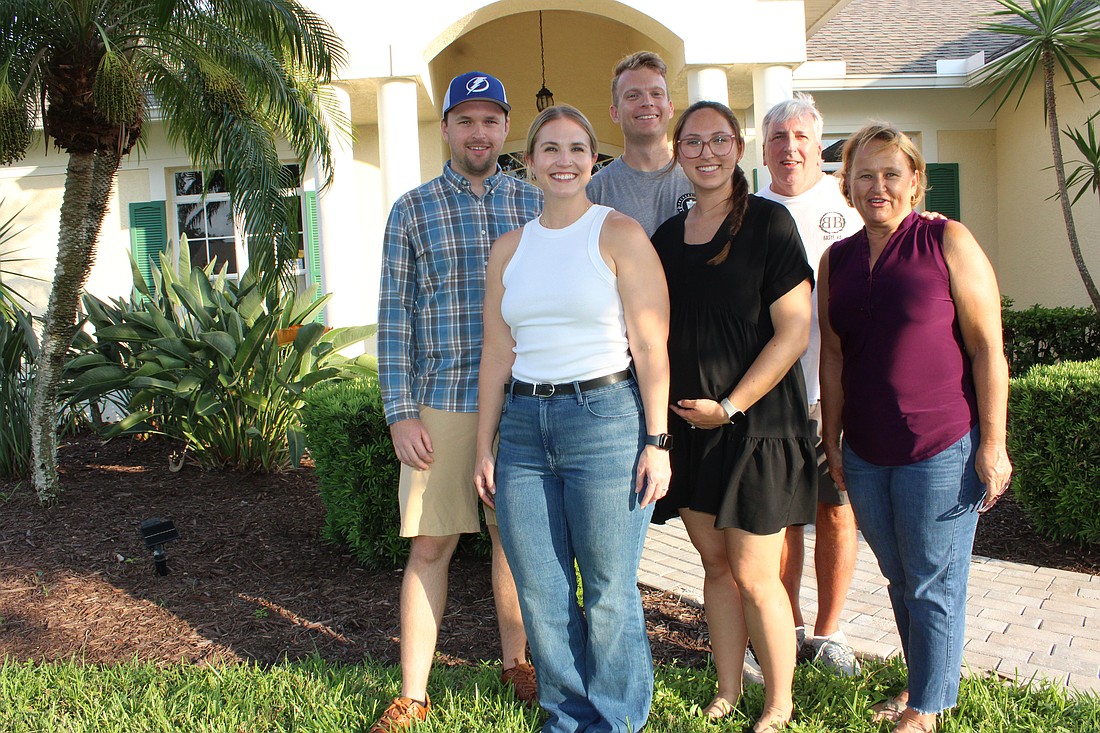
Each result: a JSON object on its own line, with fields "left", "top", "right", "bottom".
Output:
{"left": 301, "top": 378, "right": 491, "bottom": 568}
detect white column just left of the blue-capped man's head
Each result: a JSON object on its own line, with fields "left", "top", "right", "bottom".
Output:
{"left": 378, "top": 78, "right": 420, "bottom": 214}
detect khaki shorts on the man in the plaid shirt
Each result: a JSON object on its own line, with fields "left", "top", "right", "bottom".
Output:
{"left": 398, "top": 405, "right": 496, "bottom": 537}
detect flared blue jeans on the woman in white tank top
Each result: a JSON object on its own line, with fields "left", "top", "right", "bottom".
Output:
{"left": 496, "top": 380, "right": 653, "bottom": 733}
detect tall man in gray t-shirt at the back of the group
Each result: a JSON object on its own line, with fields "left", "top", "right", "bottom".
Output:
{"left": 589, "top": 51, "right": 695, "bottom": 236}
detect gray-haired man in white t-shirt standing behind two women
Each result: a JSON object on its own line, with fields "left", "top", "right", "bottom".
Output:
{"left": 758, "top": 94, "right": 864, "bottom": 675}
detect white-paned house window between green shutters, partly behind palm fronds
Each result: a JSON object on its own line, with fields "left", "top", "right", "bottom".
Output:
{"left": 173, "top": 164, "right": 306, "bottom": 278}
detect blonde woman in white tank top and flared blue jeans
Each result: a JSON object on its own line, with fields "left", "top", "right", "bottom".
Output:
{"left": 474, "top": 107, "right": 670, "bottom": 733}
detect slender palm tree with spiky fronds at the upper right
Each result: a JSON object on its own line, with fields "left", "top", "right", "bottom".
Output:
{"left": 981, "top": 0, "right": 1100, "bottom": 314}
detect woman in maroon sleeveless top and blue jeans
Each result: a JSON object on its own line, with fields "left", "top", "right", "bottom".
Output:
{"left": 818, "top": 123, "right": 1012, "bottom": 733}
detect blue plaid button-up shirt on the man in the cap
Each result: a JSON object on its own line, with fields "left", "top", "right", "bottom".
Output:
{"left": 378, "top": 163, "right": 542, "bottom": 425}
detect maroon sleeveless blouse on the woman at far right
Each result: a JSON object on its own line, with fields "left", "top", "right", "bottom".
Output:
{"left": 828, "top": 212, "right": 978, "bottom": 466}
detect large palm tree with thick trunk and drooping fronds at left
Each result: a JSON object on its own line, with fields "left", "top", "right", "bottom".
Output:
{"left": 0, "top": 0, "right": 345, "bottom": 503}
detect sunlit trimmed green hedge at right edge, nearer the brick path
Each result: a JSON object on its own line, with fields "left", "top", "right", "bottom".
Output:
{"left": 1009, "top": 359, "right": 1100, "bottom": 544}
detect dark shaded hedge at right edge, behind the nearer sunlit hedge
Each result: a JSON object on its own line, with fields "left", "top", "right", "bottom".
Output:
{"left": 1001, "top": 297, "right": 1100, "bottom": 376}
